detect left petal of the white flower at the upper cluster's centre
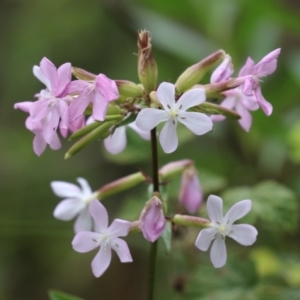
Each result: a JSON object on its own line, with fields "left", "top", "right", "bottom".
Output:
{"left": 135, "top": 108, "right": 170, "bottom": 131}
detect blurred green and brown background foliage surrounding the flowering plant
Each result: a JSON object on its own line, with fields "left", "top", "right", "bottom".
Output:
{"left": 0, "top": 0, "right": 300, "bottom": 300}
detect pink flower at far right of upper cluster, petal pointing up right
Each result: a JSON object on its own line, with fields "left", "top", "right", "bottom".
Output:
{"left": 240, "top": 48, "right": 281, "bottom": 116}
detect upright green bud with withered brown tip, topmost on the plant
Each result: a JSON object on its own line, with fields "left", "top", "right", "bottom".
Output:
{"left": 137, "top": 30, "right": 158, "bottom": 93}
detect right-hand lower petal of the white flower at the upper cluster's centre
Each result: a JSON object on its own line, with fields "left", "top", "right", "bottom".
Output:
{"left": 178, "top": 111, "right": 213, "bottom": 135}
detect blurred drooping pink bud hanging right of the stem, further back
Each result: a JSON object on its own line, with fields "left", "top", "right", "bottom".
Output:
{"left": 179, "top": 167, "right": 203, "bottom": 213}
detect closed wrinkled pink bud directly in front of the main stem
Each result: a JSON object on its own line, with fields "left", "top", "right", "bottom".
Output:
{"left": 140, "top": 196, "right": 166, "bottom": 242}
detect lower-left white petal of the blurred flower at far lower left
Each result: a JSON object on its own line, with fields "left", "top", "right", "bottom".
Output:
{"left": 53, "top": 199, "right": 85, "bottom": 221}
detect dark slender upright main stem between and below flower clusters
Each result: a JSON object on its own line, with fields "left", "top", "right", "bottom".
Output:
{"left": 148, "top": 128, "right": 159, "bottom": 300}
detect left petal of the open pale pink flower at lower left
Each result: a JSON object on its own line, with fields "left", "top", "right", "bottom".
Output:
{"left": 72, "top": 231, "right": 100, "bottom": 253}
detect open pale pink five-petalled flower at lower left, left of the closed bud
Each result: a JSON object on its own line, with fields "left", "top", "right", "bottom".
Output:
{"left": 72, "top": 200, "right": 132, "bottom": 277}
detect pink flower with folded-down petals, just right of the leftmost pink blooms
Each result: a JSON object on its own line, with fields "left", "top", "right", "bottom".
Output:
{"left": 70, "top": 74, "right": 119, "bottom": 121}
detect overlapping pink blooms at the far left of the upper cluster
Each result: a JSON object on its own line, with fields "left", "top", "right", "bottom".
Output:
{"left": 14, "top": 57, "right": 72, "bottom": 155}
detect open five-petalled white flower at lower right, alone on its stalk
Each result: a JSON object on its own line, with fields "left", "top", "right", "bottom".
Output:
{"left": 195, "top": 195, "right": 257, "bottom": 268}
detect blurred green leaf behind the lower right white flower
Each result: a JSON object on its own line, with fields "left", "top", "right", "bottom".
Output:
{"left": 222, "top": 181, "right": 299, "bottom": 231}
